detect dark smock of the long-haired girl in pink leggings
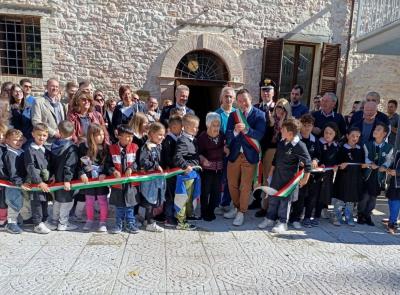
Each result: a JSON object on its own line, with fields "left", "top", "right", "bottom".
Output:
{"left": 78, "top": 142, "right": 110, "bottom": 196}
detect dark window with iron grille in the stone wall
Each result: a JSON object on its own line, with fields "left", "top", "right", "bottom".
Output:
{"left": 0, "top": 15, "right": 42, "bottom": 77}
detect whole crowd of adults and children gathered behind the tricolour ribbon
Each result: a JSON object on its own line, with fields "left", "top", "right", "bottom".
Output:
{"left": 0, "top": 79, "right": 400, "bottom": 234}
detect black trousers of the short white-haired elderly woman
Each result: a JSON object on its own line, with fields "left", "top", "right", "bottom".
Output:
{"left": 200, "top": 170, "right": 222, "bottom": 218}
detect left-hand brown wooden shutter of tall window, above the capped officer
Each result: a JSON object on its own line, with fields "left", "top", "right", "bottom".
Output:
{"left": 261, "top": 38, "right": 283, "bottom": 100}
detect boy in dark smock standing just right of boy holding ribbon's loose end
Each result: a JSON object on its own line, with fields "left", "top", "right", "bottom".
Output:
{"left": 289, "top": 114, "right": 320, "bottom": 229}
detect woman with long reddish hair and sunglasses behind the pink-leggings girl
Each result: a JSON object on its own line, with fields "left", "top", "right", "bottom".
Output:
{"left": 68, "top": 90, "right": 109, "bottom": 143}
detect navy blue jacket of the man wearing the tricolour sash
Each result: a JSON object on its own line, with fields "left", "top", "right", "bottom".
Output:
{"left": 226, "top": 107, "right": 266, "bottom": 164}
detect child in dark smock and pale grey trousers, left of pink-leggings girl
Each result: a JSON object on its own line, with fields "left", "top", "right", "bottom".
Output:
{"left": 50, "top": 121, "right": 79, "bottom": 231}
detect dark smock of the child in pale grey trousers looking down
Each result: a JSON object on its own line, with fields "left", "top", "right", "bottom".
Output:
{"left": 50, "top": 139, "right": 79, "bottom": 203}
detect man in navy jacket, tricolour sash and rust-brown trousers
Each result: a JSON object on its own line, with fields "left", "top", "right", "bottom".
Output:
{"left": 224, "top": 89, "right": 266, "bottom": 226}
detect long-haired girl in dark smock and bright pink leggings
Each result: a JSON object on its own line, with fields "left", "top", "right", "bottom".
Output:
{"left": 79, "top": 124, "right": 110, "bottom": 232}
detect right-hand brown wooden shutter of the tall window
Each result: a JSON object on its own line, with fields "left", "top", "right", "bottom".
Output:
{"left": 318, "top": 43, "right": 340, "bottom": 95}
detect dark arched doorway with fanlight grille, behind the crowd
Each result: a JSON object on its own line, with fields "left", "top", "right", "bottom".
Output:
{"left": 175, "top": 50, "right": 229, "bottom": 130}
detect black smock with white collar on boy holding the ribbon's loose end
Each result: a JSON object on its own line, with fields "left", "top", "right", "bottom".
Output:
{"left": 271, "top": 136, "right": 311, "bottom": 190}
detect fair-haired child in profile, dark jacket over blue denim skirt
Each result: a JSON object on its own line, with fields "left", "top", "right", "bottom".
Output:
{"left": 139, "top": 122, "right": 165, "bottom": 232}
